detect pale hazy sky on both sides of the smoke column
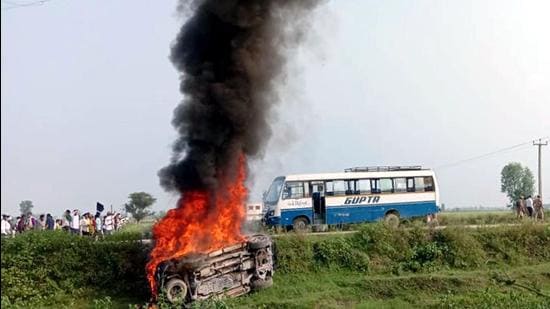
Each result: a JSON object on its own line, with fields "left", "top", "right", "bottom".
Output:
{"left": 1, "top": 0, "right": 550, "bottom": 215}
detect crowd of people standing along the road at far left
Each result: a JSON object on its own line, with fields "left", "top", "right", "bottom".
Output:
{"left": 2, "top": 209, "right": 127, "bottom": 238}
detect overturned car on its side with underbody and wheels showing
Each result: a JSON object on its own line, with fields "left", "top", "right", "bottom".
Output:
{"left": 156, "top": 235, "right": 274, "bottom": 304}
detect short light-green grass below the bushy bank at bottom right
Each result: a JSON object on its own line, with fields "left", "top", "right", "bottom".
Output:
{"left": 226, "top": 263, "right": 550, "bottom": 308}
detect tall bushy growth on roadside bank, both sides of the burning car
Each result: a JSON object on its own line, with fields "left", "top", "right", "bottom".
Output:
{"left": 2, "top": 224, "right": 550, "bottom": 307}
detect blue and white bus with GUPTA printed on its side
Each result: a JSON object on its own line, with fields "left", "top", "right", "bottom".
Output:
{"left": 263, "top": 166, "right": 440, "bottom": 230}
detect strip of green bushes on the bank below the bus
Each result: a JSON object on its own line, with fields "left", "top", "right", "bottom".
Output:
{"left": 275, "top": 224, "right": 550, "bottom": 274}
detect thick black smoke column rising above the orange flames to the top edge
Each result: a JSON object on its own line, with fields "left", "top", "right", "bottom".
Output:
{"left": 159, "top": 0, "right": 319, "bottom": 192}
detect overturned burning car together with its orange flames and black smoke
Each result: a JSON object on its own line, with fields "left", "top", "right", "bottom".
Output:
{"left": 149, "top": 0, "right": 320, "bottom": 303}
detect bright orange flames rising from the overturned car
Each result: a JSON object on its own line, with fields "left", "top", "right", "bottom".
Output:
{"left": 146, "top": 155, "right": 248, "bottom": 298}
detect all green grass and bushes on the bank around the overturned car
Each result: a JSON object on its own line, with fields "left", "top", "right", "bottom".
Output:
{"left": 2, "top": 222, "right": 550, "bottom": 308}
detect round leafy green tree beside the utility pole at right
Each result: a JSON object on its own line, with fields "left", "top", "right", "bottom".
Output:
{"left": 500, "top": 162, "right": 535, "bottom": 205}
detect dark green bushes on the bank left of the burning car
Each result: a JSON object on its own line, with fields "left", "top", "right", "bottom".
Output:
{"left": 2, "top": 231, "right": 147, "bottom": 304}
